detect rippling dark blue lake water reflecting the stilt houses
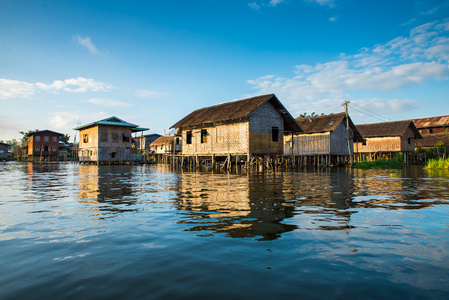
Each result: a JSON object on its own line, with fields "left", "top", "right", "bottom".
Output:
{"left": 0, "top": 162, "right": 449, "bottom": 299}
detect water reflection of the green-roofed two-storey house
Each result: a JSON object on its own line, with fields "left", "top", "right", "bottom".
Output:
{"left": 78, "top": 165, "right": 137, "bottom": 219}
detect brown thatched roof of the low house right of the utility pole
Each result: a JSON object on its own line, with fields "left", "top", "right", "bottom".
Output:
{"left": 356, "top": 120, "right": 422, "bottom": 139}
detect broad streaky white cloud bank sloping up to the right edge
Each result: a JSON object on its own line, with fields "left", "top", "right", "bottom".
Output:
{"left": 248, "top": 20, "right": 449, "bottom": 110}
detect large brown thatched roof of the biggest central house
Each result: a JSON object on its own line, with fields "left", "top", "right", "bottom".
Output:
{"left": 170, "top": 94, "right": 302, "bottom": 132}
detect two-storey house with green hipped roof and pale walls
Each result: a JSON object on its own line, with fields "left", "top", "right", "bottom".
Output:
{"left": 75, "top": 116, "right": 148, "bottom": 163}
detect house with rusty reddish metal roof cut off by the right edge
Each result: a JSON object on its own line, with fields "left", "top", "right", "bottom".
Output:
{"left": 413, "top": 116, "right": 449, "bottom": 152}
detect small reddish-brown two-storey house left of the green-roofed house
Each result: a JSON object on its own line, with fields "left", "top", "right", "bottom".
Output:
{"left": 27, "top": 130, "right": 62, "bottom": 161}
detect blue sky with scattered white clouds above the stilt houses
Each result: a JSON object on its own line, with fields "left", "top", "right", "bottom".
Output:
{"left": 0, "top": 0, "right": 449, "bottom": 140}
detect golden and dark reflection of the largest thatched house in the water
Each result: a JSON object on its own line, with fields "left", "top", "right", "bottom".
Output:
{"left": 178, "top": 173, "right": 297, "bottom": 240}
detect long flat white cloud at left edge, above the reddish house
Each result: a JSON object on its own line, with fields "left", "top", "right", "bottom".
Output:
{"left": 0, "top": 77, "right": 114, "bottom": 99}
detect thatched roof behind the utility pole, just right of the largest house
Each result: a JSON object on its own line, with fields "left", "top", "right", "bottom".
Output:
{"left": 295, "top": 112, "right": 363, "bottom": 141}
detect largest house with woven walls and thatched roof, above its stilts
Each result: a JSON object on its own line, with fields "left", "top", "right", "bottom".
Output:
{"left": 171, "top": 94, "right": 301, "bottom": 158}
